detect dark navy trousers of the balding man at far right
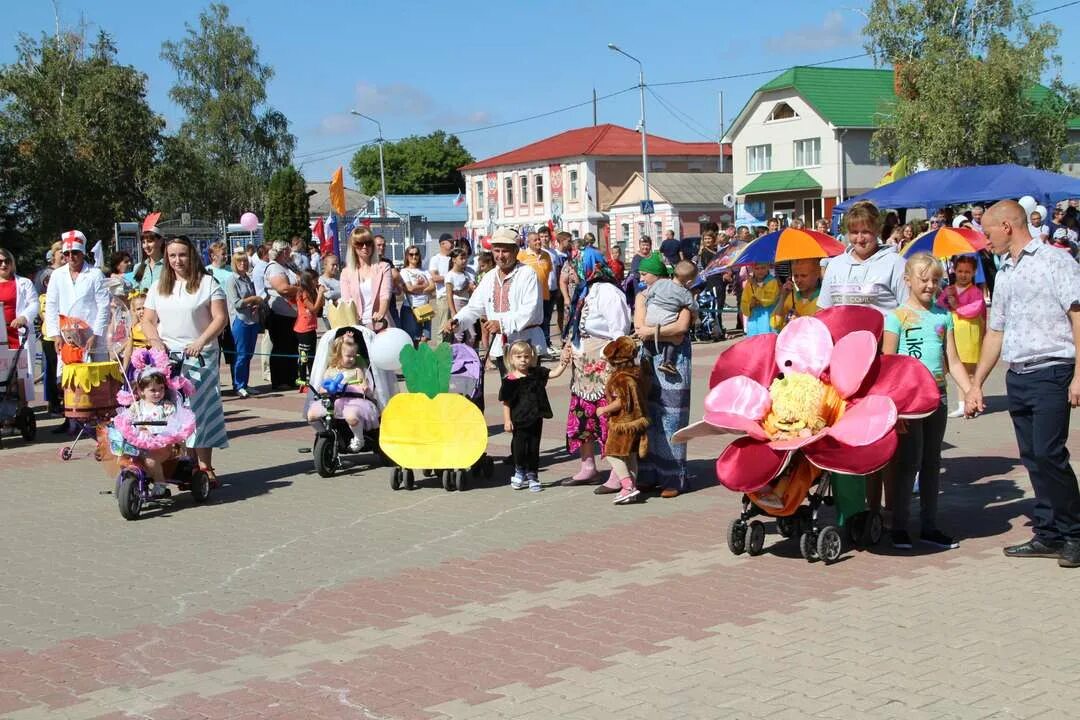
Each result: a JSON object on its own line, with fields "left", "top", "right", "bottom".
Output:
{"left": 1005, "top": 361, "right": 1080, "bottom": 546}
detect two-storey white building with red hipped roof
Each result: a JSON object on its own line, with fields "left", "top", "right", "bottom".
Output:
{"left": 461, "top": 124, "right": 731, "bottom": 244}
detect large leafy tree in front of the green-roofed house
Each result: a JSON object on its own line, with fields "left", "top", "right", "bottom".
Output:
{"left": 865, "top": 0, "right": 1080, "bottom": 171}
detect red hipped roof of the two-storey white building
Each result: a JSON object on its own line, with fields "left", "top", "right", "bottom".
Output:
{"left": 461, "top": 123, "right": 731, "bottom": 171}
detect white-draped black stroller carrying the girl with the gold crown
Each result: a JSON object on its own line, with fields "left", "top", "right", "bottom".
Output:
{"left": 303, "top": 325, "right": 397, "bottom": 477}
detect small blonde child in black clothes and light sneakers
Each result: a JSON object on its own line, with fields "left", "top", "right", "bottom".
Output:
{"left": 499, "top": 340, "right": 568, "bottom": 492}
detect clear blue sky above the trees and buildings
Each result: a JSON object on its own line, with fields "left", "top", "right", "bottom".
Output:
{"left": 6, "top": 0, "right": 1080, "bottom": 192}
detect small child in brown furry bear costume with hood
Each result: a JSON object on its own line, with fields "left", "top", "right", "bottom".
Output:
{"left": 596, "top": 336, "right": 649, "bottom": 505}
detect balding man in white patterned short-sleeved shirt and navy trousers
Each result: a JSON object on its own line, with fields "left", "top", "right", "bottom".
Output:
{"left": 967, "top": 200, "right": 1080, "bottom": 568}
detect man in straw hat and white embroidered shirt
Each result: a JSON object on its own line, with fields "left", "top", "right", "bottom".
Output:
{"left": 442, "top": 228, "right": 548, "bottom": 375}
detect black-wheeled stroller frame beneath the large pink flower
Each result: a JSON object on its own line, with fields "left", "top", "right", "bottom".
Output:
{"left": 728, "top": 454, "right": 882, "bottom": 562}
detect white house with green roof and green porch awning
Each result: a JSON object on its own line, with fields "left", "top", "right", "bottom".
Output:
{"left": 724, "top": 66, "right": 1080, "bottom": 223}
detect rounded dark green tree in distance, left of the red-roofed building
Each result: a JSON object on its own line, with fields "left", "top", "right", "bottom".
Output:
{"left": 349, "top": 130, "right": 475, "bottom": 195}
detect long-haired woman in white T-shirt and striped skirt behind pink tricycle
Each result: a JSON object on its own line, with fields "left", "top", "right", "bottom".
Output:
{"left": 143, "top": 235, "right": 229, "bottom": 487}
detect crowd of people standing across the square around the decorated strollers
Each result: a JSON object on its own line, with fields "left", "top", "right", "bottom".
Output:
{"left": 0, "top": 194, "right": 1080, "bottom": 566}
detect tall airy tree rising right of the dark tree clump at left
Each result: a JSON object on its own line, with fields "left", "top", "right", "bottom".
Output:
{"left": 156, "top": 3, "right": 296, "bottom": 220}
